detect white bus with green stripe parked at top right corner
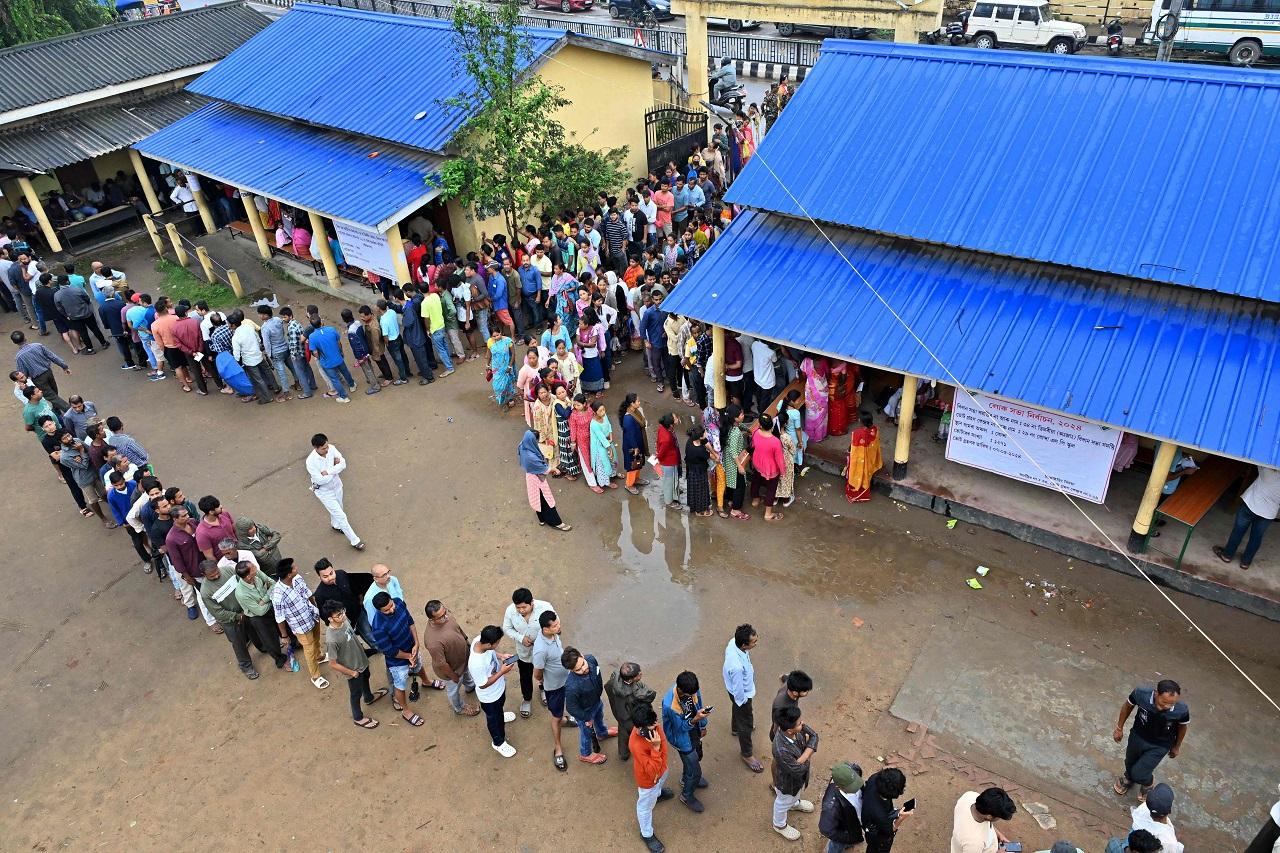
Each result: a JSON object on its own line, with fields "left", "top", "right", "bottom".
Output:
{"left": 1144, "top": 0, "right": 1280, "bottom": 65}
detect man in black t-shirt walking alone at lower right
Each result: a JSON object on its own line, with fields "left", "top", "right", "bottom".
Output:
{"left": 1111, "top": 679, "right": 1192, "bottom": 802}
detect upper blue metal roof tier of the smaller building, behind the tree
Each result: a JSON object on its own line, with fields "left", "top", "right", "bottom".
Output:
{"left": 189, "top": 3, "right": 566, "bottom": 152}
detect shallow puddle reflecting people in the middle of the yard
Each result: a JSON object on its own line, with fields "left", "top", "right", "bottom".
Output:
{"left": 572, "top": 487, "right": 701, "bottom": 667}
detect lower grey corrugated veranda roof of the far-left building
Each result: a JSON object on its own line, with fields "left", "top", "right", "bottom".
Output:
{"left": 0, "top": 91, "right": 209, "bottom": 173}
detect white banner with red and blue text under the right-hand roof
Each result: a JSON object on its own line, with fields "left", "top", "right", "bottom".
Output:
{"left": 947, "top": 393, "right": 1123, "bottom": 503}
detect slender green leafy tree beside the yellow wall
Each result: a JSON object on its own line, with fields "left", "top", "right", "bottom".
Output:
{"left": 436, "top": 0, "right": 627, "bottom": 234}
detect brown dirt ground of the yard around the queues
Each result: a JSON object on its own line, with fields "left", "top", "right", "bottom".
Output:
{"left": 0, "top": 240, "right": 1280, "bottom": 853}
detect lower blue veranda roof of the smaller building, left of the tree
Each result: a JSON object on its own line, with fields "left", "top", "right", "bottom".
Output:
{"left": 134, "top": 104, "right": 440, "bottom": 231}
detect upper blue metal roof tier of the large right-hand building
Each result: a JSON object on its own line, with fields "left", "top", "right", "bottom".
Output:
{"left": 728, "top": 44, "right": 1280, "bottom": 302}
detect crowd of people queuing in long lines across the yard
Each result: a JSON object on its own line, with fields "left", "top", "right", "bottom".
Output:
{"left": 0, "top": 141, "right": 1228, "bottom": 853}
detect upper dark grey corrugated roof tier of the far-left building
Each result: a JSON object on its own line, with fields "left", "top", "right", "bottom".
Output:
{"left": 0, "top": 3, "right": 270, "bottom": 113}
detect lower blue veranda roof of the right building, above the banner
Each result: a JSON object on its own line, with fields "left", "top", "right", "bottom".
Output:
{"left": 663, "top": 211, "right": 1280, "bottom": 466}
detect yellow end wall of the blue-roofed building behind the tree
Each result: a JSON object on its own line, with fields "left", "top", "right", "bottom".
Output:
{"left": 448, "top": 45, "right": 650, "bottom": 254}
